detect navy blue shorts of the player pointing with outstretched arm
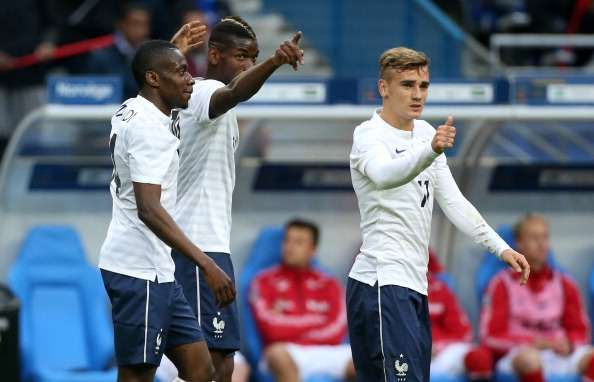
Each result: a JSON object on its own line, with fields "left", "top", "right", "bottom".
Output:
{"left": 171, "top": 250, "right": 239, "bottom": 355}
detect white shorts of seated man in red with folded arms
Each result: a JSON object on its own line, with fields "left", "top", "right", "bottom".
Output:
{"left": 286, "top": 344, "right": 352, "bottom": 379}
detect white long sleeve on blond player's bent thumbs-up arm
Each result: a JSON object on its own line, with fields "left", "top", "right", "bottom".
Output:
{"left": 350, "top": 128, "right": 438, "bottom": 189}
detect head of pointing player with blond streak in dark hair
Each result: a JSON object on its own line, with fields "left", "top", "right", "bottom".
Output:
{"left": 208, "top": 16, "right": 259, "bottom": 84}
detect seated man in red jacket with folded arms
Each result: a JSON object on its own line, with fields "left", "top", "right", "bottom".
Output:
{"left": 249, "top": 219, "right": 355, "bottom": 382}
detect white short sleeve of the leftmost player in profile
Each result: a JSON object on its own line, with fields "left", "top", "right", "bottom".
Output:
{"left": 126, "top": 125, "right": 178, "bottom": 184}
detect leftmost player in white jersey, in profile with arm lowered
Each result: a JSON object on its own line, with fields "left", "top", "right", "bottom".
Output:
{"left": 99, "top": 35, "right": 235, "bottom": 382}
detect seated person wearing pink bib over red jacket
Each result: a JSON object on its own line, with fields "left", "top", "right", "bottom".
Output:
{"left": 480, "top": 214, "right": 594, "bottom": 382}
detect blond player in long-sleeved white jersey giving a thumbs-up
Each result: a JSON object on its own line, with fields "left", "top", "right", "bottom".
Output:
{"left": 347, "top": 48, "right": 529, "bottom": 382}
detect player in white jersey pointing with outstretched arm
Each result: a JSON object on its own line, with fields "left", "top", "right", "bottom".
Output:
{"left": 173, "top": 17, "right": 303, "bottom": 382}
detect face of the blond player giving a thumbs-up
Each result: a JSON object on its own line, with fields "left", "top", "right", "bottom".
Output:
{"left": 379, "top": 66, "right": 429, "bottom": 120}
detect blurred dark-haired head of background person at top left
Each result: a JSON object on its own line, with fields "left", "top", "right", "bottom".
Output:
{"left": 116, "top": 2, "right": 151, "bottom": 47}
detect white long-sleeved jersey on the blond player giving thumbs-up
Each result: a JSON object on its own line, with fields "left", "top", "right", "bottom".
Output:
{"left": 349, "top": 112, "right": 509, "bottom": 295}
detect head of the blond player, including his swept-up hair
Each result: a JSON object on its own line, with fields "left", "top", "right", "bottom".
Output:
{"left": 378, "top": 47, "right": 429, "bottom": 120}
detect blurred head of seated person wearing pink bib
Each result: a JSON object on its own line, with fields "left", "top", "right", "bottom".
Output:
{"left": 514, "top": 213, "right": 550, "bottom": 270}
